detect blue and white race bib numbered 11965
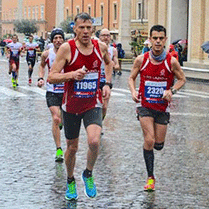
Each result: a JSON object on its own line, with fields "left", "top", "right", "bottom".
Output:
{"left": 74, "top": 73, "right": 99, "bottom": 98}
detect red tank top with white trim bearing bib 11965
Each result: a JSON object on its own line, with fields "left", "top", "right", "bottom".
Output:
{"left": 62, "top": 40, "right": 102, "bottom": 114}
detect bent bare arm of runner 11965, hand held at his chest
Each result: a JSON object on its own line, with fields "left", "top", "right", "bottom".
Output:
{"left": 48, "top": 43, "right": 86, "bottom": 83}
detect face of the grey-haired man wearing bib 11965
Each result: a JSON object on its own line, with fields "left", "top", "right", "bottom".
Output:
{"left": 74, "top": 19, "right": 92, "bottom": 44}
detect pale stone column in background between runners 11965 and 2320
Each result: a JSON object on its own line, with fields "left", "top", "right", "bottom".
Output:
{"left": 118, "top": 0, "right": 132, "bottom": 58}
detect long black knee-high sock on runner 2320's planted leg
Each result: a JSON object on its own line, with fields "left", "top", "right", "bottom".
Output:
{"left": 144, "top": 149, "right": 154, "bottom": 177}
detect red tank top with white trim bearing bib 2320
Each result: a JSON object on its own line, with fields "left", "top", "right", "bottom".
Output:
{"left": 139, "top": 52, "right": 174, "bottom": 112}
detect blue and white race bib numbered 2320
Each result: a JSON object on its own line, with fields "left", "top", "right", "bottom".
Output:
{"left": 145, "top": 81, "right": 167, "bottom": 103}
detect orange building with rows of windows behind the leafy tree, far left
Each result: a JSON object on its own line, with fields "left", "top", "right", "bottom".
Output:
{"left": 1, "top": 0, "right": 57, "bottom": 37}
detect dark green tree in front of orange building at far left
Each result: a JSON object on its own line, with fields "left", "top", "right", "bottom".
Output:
{"left": 14, "top": 20, "right": 39, "bottom": 35}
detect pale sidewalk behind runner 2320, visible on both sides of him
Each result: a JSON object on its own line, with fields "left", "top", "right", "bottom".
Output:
{"left": 122, "top": 63, "right": 209, "bottom": 82}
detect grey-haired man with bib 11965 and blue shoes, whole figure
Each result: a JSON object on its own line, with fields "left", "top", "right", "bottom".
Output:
{"left": 48, "top": 13, "right": 113, "bottom": 200}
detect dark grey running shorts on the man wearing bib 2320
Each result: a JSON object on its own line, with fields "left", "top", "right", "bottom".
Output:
{"left": 136, "top": 107, "right": 170, "bottom": 125}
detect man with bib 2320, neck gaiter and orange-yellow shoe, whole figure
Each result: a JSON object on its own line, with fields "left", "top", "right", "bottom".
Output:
{"left": 129, "top": 25, "right": 186, "bottom": 191}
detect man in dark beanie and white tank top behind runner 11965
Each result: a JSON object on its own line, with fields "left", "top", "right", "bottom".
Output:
{"left": 38, "top": 28, "right": 64, "bottom": 162}
